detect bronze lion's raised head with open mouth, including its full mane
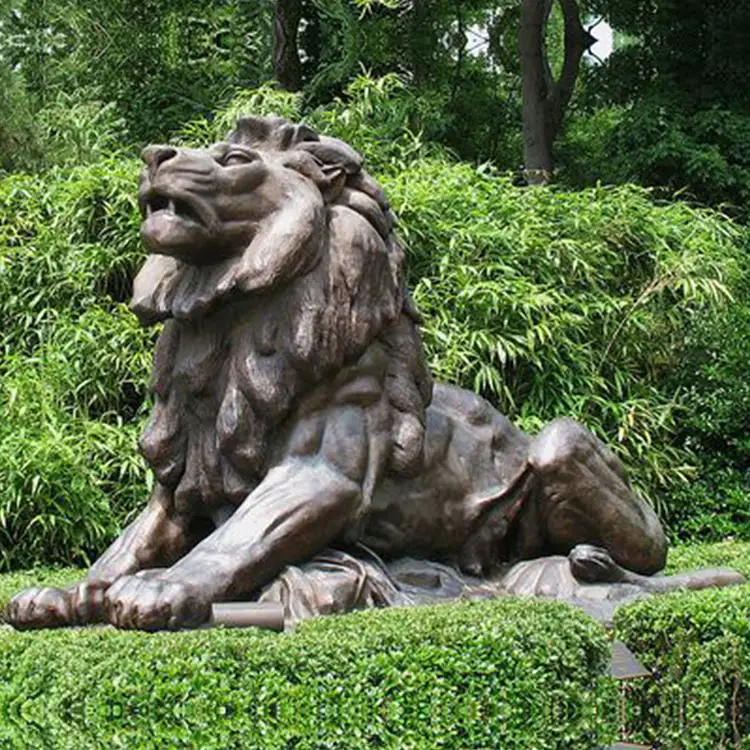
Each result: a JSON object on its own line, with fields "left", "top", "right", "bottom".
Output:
{"left": 132, "top": 117, "right": 431, "bottom": 516}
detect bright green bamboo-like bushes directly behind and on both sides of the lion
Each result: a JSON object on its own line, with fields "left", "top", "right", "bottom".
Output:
{"left": 0, "top": 78, "right": 741, "bottom": 569}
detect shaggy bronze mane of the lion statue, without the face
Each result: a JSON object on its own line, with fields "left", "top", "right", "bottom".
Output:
{"left": 132, "top": 117, "right": 432, "bottom": 508}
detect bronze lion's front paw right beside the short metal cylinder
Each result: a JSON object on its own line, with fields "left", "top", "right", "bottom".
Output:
{"left": 104, "top": 576, "right": 211, "bottom": 630}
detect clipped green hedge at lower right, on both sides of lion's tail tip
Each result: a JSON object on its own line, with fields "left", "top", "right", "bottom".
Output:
{"left": 614, "top": 543, "right": 750, "bottom": 750}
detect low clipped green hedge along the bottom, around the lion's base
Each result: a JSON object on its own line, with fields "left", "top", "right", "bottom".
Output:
{"left": 0, "top": 543, "right": 750, "bottom": 750}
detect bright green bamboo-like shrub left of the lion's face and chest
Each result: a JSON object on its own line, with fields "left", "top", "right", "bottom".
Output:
{"left": 0, "top": 158, "right": 153, "bottom": 569}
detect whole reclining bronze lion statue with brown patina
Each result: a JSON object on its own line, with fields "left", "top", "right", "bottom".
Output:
{"left": 8, "top": 118, "right": 748, "bottom": 630}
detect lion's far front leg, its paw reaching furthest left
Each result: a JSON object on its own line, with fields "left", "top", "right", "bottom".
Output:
{"left": 6, "top": 486, "right": 191, "bottom": 629}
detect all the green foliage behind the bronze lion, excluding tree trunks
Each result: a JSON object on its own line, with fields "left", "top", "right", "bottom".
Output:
{"left": 0, "top": 0, "right": 750, "bottom": 569}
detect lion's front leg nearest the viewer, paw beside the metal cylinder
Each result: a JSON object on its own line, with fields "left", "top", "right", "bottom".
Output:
{"left": 105, "top": 459, "right": 362, "bottom": 630}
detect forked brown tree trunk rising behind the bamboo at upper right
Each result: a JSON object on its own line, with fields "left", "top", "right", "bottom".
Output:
{"left": 518, "top": 0, "right": 595, "bottom": 185}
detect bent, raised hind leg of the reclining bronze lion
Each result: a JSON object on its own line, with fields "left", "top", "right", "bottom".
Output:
{"left": 529, "top": 419, "right": 667, "bottom": 579}
